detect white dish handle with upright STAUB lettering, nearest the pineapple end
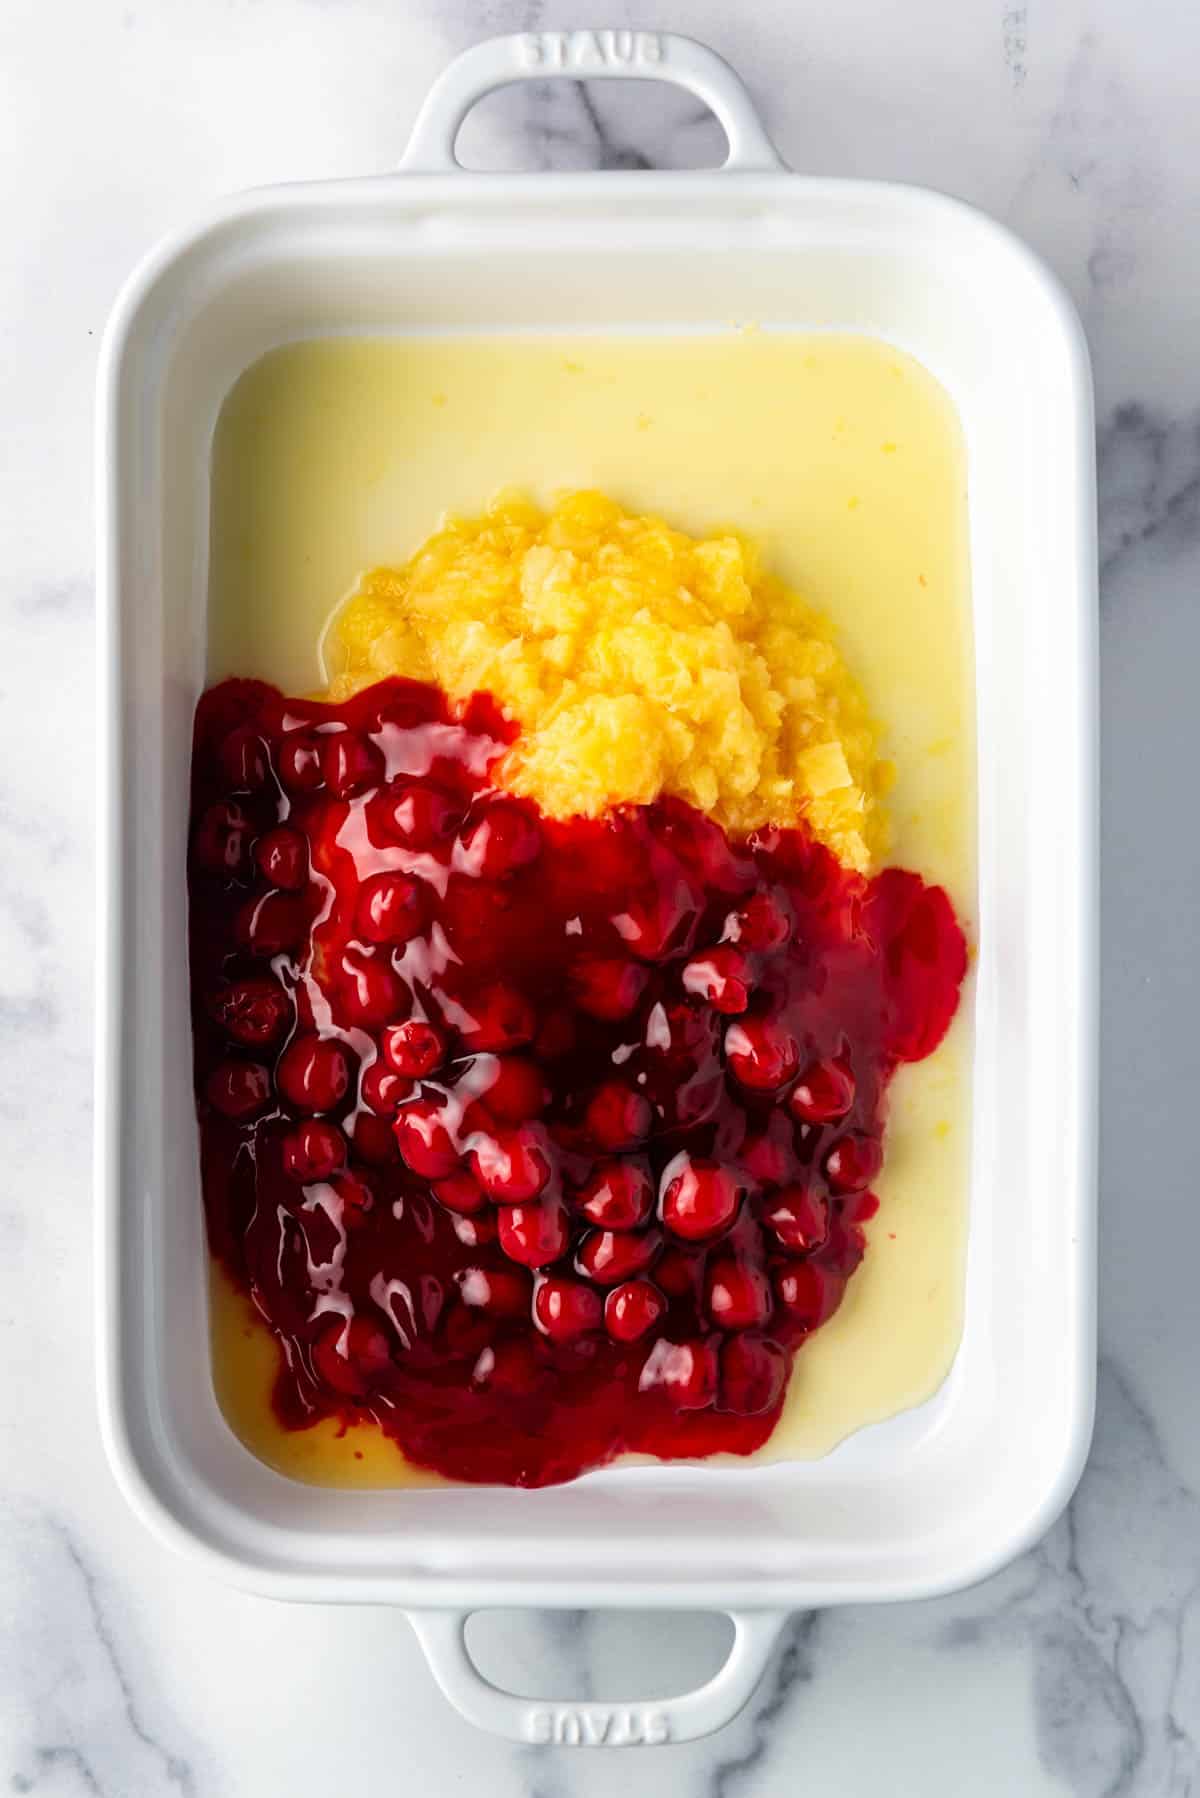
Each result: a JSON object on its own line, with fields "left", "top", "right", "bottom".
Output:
{"left": 399, "top": 29, "right": 784, "bottom": 174}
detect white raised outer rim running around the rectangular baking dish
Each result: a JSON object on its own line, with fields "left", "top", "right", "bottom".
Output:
{"left": 95, "top": 171, "right": 1097, "bottom": 1607}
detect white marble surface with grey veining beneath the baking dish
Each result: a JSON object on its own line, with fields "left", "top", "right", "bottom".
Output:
{"left": 0, "top": 0, "right": 1200, "bottom": 1798}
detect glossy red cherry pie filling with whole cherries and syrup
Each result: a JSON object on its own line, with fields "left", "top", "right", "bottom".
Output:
{"left": 189, "top": 681, "right": 966, "bottom": 1485}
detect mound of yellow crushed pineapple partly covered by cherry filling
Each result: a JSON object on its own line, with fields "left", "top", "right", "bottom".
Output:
{"left": 326, "top": 493, "right": 889, "bottom": 868}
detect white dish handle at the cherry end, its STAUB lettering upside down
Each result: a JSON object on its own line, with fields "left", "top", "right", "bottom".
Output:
{"left": 408, "top": 1611, "right": 788, "bottom": 1748}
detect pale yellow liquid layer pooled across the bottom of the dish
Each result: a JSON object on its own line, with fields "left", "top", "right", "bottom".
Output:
{"left": 209, "top": 329, "right": 975, "bottom": 1485}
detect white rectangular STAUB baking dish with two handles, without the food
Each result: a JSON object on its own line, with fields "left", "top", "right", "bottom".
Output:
{"left": 97, "top": 32, "right": 1096, "bottom": 1744}
